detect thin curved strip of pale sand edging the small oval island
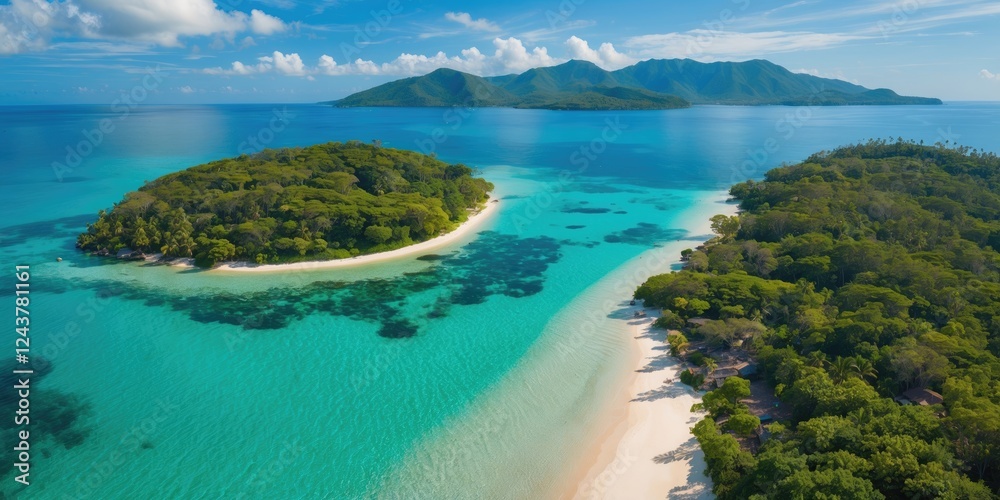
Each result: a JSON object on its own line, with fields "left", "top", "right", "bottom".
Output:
{"left": 170, "top": 197, "right": 500, "bottom": 273}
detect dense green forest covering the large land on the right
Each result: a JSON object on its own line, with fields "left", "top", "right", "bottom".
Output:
{"left": 635, "top": 139, "right": 1000, "bottom": 499}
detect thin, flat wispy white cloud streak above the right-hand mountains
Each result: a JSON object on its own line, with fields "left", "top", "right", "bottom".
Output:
{"left": 625, "top": 29, "right": 871, "bottom": 61}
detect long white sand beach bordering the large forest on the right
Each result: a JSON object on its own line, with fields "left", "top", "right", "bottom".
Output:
{"left": 561, "top": 193, "right": 738, "bottom": 499}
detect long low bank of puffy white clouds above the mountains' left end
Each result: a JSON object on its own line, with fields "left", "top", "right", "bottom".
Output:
{"left": 214, "top": 37, "right": 565, "bottom": 76}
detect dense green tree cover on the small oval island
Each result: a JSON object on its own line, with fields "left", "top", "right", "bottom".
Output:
{"left": 77, "top": 141, "right": 493, "bottom": 267}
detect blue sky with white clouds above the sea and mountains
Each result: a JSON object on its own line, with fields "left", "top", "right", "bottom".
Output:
{"left": 0, "top": 0, "right": 1000, "bottom": 104}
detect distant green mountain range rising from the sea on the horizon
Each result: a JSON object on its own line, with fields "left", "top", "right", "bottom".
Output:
{"left": 324, "top": 59, "right": 941, "bottom": 110}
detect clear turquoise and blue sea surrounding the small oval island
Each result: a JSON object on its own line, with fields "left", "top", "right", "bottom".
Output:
{"left": 0, "top": 104, "right": 1000, "bottom": 498}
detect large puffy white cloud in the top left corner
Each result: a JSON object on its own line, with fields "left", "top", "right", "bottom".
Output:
{"left": 0, "top": 0, "right": 287, "bottom": 54}
